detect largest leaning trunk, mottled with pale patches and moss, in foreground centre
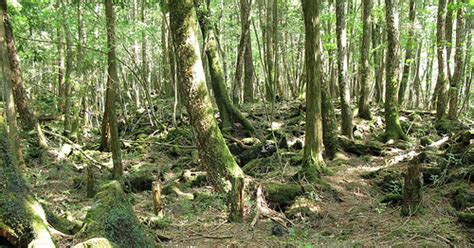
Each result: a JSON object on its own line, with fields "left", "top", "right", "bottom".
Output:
{"left": 170, "top": 0, "right": 244, "bottom": 221}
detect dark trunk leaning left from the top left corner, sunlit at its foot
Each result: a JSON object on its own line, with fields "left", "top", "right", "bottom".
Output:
{"left": 0, "top": 0, "right": 48, "bottom": 149}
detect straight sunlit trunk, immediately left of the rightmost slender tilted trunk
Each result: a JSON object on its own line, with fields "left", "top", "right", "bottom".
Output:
{"left": 435, "top": 0, "right": 448, "bottom": 121}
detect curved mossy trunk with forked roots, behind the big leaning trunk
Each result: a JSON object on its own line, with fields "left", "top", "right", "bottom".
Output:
{"left": 194, "top": 0, "right": 254, "bottom": 132}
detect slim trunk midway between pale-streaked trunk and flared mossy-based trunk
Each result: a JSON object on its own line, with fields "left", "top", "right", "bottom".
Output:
{"left": 359, "top": 0, "right": 372, "bottom": 120}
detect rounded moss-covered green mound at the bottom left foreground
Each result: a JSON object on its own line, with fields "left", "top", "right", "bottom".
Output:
{"left": 78, "top": 181, "right": 155, "bottom": 247}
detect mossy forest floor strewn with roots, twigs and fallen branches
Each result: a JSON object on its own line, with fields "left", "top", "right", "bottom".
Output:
{"left": 27, "top": 102, "right": 474, "bottom": 247}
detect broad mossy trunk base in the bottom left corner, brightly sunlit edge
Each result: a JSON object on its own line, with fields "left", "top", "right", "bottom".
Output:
{"left": 0, "top": 116, "right": 55, "bottom": 248}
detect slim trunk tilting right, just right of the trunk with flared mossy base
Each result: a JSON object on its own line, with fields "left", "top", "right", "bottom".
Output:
{"left": 398, "top": 0, "right": 415, "bottom": 107}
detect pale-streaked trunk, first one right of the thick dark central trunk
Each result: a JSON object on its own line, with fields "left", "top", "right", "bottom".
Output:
{"left": 336, "top": 0, "right": 352, "bottom": 138}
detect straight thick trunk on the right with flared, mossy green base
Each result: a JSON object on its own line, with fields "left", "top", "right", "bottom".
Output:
{"left": 384, "top": 0, "right": 405, "bottom": 140}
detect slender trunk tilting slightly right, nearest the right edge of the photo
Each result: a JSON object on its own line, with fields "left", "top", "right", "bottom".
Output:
{"left": 448, "top": 0, "right": 466, "bottom": 120}
